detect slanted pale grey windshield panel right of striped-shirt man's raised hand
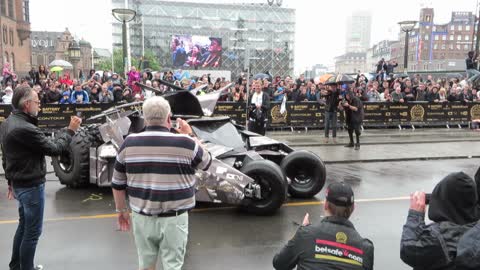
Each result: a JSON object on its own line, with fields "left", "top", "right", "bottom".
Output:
{"left": 190, "top": 121, "right": 245, "bottom": 149}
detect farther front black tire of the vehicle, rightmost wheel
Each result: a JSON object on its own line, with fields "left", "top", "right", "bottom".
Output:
{"left": 280, "top": 150, "right": 327, "bottom": 198}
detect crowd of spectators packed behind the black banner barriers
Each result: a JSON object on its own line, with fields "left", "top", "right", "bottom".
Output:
{"left": 1, "top": 63, "right": 480, "bottom": 104}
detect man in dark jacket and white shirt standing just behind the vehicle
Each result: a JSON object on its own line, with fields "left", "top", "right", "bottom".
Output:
{"left": 248, "top": 81, "right": 270, "bottom": 135}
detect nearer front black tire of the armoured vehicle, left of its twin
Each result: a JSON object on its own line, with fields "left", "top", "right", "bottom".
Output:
{"left": 240, "top": 160, "right": 287, "bottom": 215}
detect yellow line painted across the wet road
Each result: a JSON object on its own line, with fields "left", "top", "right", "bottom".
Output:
{"left": 0, "top": 197, "right": 410, "bottom": 225}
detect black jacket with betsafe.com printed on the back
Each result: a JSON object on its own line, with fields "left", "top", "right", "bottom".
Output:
{"left": 273, "top": 217, "right": 373, "bottom": 270}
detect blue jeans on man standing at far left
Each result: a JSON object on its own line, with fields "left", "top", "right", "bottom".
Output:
{"left": 9, "top": 184, "right": 45, "bottom": 270}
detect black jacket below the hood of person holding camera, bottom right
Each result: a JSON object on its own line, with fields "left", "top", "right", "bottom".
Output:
{"left": 400, "top": 210, "right": 480, "bottom": 270}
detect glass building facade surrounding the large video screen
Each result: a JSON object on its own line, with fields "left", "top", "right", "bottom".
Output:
{"left": 112, "top": 0, "right": 295, "bottom": 76}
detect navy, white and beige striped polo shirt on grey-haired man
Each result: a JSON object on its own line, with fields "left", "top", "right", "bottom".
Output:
{"left": 112, "top": 126, "right": 212, "bottom": 215}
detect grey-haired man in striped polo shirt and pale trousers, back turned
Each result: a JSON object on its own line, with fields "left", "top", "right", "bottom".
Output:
{"left": 112, "top": 97, "right": 212, "bottom": 270}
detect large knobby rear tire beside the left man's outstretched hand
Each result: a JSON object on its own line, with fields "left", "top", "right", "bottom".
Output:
{"left": 52, "top": 128, "right": 93, "bottom": 188}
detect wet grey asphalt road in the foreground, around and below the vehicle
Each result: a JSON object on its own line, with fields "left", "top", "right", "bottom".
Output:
{"left": 0, "top": 156, "right": 480, "bottom": 270}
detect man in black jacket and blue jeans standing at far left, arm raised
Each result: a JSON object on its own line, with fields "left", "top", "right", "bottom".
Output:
{"left": 0, "top": 86, "right": 82, "bottom": 270}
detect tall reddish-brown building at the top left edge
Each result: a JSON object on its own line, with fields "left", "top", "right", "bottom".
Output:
{"left": 0, "top": 0, "right": 31, "bottom": 77}
